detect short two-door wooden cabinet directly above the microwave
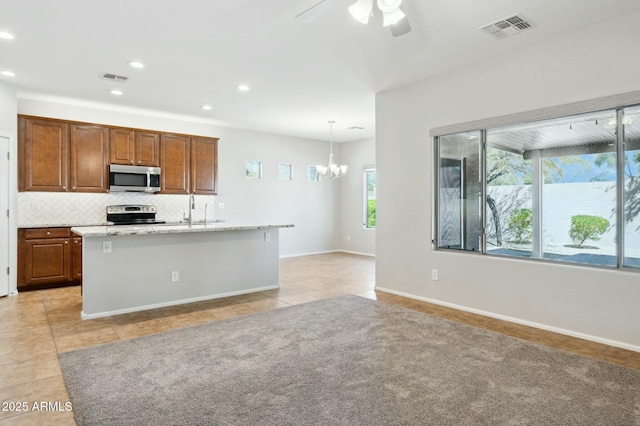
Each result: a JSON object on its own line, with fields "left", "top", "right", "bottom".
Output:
{"left": 110, "top": 129, "right": 160, "bottom": 167}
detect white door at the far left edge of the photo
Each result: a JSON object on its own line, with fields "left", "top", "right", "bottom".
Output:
{"left": 0, "top": 135, "right": 11, "bottom": 297}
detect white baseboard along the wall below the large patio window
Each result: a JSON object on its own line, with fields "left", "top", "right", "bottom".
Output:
{"left": 376, "top": 287, "right": 640, "bottom": 352}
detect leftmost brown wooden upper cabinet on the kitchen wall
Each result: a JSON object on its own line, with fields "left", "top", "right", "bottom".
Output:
{"left": 18, "top": 116, "right": 69, "bottom": 191}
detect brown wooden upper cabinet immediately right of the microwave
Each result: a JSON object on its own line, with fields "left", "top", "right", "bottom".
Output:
{"left": 160, "top": 135, "right": 190, "bottom": 194}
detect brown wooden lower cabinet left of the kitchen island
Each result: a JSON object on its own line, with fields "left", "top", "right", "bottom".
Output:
{"left": 18, "top": 228, "right": 82, "bottom": 291}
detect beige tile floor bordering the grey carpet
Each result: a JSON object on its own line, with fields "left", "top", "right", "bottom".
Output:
{"left": 0, "top": 253, "right": 640, "bottom": 426}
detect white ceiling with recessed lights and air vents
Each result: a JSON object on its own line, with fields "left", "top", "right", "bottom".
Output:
{"left": 0, "top": 0, "right": 640, "bottom": 141}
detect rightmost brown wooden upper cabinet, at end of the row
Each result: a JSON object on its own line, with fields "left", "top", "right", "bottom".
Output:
{"left": 191, "top": 137, "right": 218, "bottom": 195}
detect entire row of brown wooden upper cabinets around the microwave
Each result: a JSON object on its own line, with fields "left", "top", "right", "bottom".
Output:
{"left": 18, "top": 116, "right": 218, "bottom": 195}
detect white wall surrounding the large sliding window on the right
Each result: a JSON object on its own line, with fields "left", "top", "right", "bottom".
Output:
{"left": 376, "top": 14, "right": 640, "bottom": 351}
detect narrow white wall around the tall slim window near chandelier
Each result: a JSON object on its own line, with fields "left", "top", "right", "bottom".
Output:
{"left": 336, "top": 139, "right": 376, "bottom": 256}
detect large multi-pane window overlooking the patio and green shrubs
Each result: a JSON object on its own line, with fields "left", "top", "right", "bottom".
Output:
{"left": 434, "top": 107, "right": 640, "bottom": 268}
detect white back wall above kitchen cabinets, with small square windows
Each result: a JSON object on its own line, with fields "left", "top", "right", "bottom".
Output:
{"left": 13, "top": 97, "right": 339, "bottom": 256}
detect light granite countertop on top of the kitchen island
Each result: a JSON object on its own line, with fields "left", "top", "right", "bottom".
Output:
{"left": 71, "top": 222, "right": 294, "bottom": 237}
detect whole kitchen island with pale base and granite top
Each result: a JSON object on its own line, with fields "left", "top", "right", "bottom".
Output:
{"left": 71, "top": 222, "right": 293, "bottom": 319}
